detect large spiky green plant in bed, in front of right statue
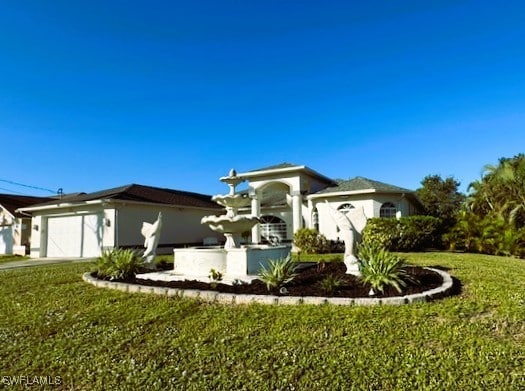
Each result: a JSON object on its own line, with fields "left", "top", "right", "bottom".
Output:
{"left": 359, "top": 243, "right": 411, "bottom": 293}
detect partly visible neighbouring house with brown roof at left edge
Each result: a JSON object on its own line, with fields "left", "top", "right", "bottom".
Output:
{"left": 0, "top": 194, "right": 51, "bottom": 255}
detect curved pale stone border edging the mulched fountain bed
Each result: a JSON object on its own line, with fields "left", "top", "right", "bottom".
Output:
{"left": 82, "top": 267, "right": 454, "bottom": 306}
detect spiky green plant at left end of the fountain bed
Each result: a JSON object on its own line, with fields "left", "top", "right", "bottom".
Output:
{"left": 96, "top": 248, "right": 144, "bottom": 280}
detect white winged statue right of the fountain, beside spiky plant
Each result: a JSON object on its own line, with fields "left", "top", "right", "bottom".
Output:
{"left": 325, "top": 201, "right": 367, "bottom": 276}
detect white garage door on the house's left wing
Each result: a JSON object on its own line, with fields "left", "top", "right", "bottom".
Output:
{"left": 47, "top": 214, "right": 103, "bottom": 257}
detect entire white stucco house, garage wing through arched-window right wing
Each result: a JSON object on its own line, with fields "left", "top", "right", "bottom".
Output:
{"left": 18, "top": 163, "right": 422, "bottom": 257}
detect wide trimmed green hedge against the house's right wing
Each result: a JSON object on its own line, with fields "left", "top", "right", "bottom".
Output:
{"left": 363, "top": 216, "right": 442, "bottom": 251}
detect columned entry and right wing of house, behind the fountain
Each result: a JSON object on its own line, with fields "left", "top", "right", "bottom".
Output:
{"left": 237, "top": 163, "right": 422, "bottom": 243}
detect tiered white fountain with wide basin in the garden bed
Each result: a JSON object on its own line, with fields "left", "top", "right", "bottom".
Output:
{"left": 170, "top": 169, "right": 291, "bottom": 282}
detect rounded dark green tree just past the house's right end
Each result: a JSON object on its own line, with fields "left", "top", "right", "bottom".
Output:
{"left": 416, "top": 175, "right": 465, "bottom": 230}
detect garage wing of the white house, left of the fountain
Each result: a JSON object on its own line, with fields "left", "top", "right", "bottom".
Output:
{"left": 20, "top": 184, "right": 223, "bottom": 257}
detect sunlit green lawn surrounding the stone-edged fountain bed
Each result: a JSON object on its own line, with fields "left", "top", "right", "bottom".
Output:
{"left": 0, "top": 253, "right": 525, "bottom": 390}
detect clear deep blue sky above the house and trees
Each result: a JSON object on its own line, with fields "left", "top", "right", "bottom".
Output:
{"left": 0, "top": 0, "right": 525, "bottom": 195}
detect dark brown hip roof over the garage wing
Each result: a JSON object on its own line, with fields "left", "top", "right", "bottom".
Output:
{"left": 26, "top": 184, "right": 221, "bottom": 209}
